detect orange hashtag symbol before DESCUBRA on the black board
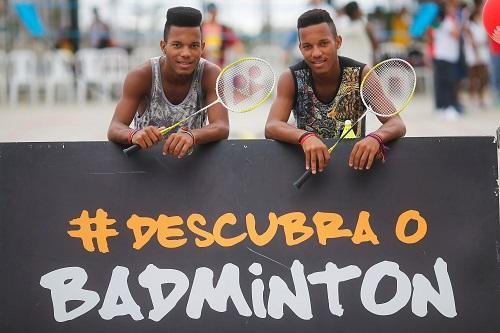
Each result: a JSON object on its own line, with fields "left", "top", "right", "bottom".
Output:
{"left": 68, "top": 208, "right": 118, "bottom": 253}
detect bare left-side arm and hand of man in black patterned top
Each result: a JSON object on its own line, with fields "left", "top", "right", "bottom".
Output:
{"left": 265, "top": 71, "right": 330, "bottom": 174}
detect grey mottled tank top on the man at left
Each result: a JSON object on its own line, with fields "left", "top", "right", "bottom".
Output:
{"left": 134, "top": 56, "right": 207, "bottom": 133}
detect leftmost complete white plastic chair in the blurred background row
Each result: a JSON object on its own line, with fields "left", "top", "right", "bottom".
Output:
{"left": 8, "top": 49, "right": 38, "bottom": 105}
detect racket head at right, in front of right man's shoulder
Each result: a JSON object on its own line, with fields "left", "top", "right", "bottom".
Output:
{"left": 360, "top": 58, "right": 417, "bottom": 117}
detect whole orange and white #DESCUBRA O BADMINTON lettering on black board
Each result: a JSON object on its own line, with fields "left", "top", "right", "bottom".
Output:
{"left": 47, "top": 209, "right": 458, "bottom": 322}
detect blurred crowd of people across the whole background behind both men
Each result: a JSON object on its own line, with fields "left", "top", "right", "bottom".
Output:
{"left": 1, "top": 0, "right": 500, "bottom": 113}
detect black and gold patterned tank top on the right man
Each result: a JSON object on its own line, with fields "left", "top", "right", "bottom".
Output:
{"left": 290, "top": 56, "right": 365, "bottom": 139}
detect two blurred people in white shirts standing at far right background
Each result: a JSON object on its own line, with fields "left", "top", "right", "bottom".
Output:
{"left": 428, "top": 0, "right": 489, "bottom": 119}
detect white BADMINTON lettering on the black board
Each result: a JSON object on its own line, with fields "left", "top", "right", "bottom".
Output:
{"left": 40, "top": 257, "right": 457, "bottom": 322}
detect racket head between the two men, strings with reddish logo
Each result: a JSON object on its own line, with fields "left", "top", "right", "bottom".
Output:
{"left": 216, "top": 57, "right": 276, "bottom": 113}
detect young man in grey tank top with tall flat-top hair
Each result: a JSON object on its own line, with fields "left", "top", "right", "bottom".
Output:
{"left": 108, "top": 7, "right": 229, "bottom": 158}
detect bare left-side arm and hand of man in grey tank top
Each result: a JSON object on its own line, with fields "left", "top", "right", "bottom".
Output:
{"left": 108, "top": 62, "right": 162, "bottom": 148}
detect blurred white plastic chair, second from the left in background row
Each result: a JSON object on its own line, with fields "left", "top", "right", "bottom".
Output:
{"left": 43, "top": 50, "right": 75, "bottom": 104}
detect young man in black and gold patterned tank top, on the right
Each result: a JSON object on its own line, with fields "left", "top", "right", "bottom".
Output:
{"left": 265, "top": 9, "right": 406, "bottom": 174}
